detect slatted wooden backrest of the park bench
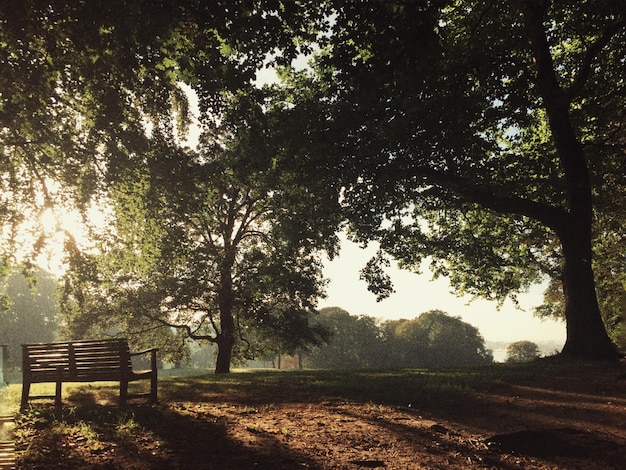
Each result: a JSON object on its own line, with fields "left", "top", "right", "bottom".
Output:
{"left": 22, "top": 339, "right": 132, "bottom": 382}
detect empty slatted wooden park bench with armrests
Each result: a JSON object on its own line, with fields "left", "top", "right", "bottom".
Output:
{"left": 22, "top": 339, "right": 157, "bottom": 409}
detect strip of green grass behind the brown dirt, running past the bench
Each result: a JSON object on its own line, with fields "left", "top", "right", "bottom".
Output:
{"left": 0, "top": 360, "right": 592, "bottom": 414}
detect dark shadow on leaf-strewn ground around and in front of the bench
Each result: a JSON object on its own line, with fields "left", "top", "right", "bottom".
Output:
{"left": 18, "top": 391, "right": 320, "bottom": 470}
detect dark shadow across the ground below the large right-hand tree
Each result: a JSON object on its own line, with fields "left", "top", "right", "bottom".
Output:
{"left": 330, "top": 368, "right": 626, "bottom": 468}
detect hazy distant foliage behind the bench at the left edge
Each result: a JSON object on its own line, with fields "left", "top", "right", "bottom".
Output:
{"left": 0, "top": 270, "right": 58, "bottom": 367}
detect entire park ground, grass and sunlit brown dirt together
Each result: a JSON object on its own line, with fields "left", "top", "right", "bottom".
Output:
{"left": 4, "top": 360, "right": 626, "bottom": 470}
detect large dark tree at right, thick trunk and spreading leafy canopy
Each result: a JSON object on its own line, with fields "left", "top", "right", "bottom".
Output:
{"left": 278, "top": 0, "right": 626, "bottom": 360}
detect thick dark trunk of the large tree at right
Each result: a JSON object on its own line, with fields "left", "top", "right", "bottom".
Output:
{"left": 515, "top": 0, "right": 617, "bottom": 360}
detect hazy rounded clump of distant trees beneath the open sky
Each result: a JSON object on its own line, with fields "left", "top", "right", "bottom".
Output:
{"left": 306, "top": 307, "right": 493, "bottom": 369}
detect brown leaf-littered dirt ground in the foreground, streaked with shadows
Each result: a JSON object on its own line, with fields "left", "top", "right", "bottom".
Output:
{"left": 17, "top": 366, "right": 626, "bottom": 470}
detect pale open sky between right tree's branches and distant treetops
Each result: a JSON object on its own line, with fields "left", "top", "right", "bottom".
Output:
{"left": 318, "top": 233, "right": 565, "bottom": 344}
